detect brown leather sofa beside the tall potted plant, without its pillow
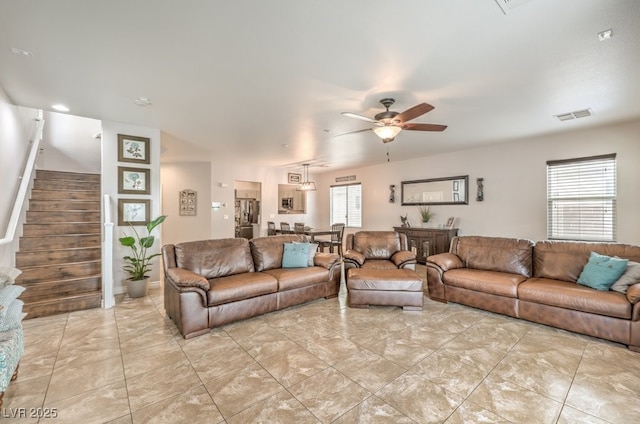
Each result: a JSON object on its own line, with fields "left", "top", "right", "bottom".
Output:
{"left": 162, "top": 234, "right": 340, "bottom": 339}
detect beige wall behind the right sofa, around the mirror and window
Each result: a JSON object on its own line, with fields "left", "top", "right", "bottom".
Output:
{"left": 316, "top": 120, "right": 640, "bottom": 244}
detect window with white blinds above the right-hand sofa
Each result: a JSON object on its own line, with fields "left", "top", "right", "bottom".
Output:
{"left": 547, "top": 154, "right": 616, "bottom": 241}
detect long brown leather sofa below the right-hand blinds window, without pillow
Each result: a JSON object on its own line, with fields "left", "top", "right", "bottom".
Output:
{"left": 427, "top": 236, "right": 640, "bottom": 351}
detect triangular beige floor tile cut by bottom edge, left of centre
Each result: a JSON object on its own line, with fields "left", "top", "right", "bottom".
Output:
{"left": 227, "top": 391, "right": 320, "bottom": 424}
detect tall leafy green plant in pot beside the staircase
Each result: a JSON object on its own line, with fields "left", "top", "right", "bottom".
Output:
{"left": 119, "top": 215, "right": 167, "bottom": 297}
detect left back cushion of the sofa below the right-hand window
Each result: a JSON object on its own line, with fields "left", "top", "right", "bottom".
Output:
{"left": 452, "top": 236, "right": 534, "bottom": 277}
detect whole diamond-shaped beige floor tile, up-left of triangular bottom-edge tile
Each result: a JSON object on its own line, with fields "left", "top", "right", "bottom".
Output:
{"left": 205, "top": 363, "right": 284, "bottom": 418}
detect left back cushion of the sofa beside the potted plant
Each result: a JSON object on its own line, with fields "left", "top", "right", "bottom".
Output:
{"left": 175, "top": 238, "right": 253, "bottom": 279}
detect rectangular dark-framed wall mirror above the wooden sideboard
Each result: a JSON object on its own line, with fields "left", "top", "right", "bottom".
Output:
{"left": 401, "top": 175, "right": 469, "bottom": 205}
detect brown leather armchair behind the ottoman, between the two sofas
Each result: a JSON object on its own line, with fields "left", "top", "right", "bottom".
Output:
{"left": 344, "top": 231, "right": 416, "bottom": 274}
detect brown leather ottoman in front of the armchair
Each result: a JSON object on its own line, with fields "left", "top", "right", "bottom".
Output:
{"left": 347, "top": 268, "right": 424, "bottom": 311}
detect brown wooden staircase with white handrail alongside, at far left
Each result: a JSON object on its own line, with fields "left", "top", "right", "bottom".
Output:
{"left": 16, "top": 170, "right": 102, "bottom": 318}
